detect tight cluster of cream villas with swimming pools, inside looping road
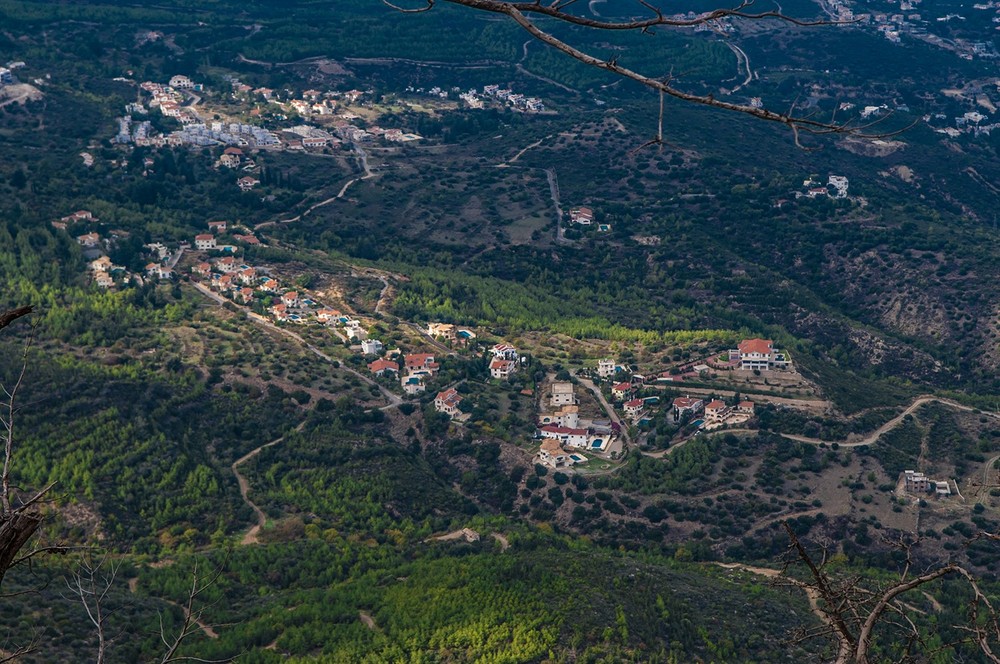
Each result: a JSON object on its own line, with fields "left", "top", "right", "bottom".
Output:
{"left": 538, "top": 381, "right": 618, "bottom": 468}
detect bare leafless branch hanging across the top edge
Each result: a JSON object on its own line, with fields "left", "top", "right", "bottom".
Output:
{"left": 381, "top": 0, "right": 908, "bottom": 149}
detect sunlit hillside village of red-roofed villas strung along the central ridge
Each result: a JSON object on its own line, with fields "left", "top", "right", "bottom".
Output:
{"left": 52, "top": 210, "right": 820, "bottom": 468}
